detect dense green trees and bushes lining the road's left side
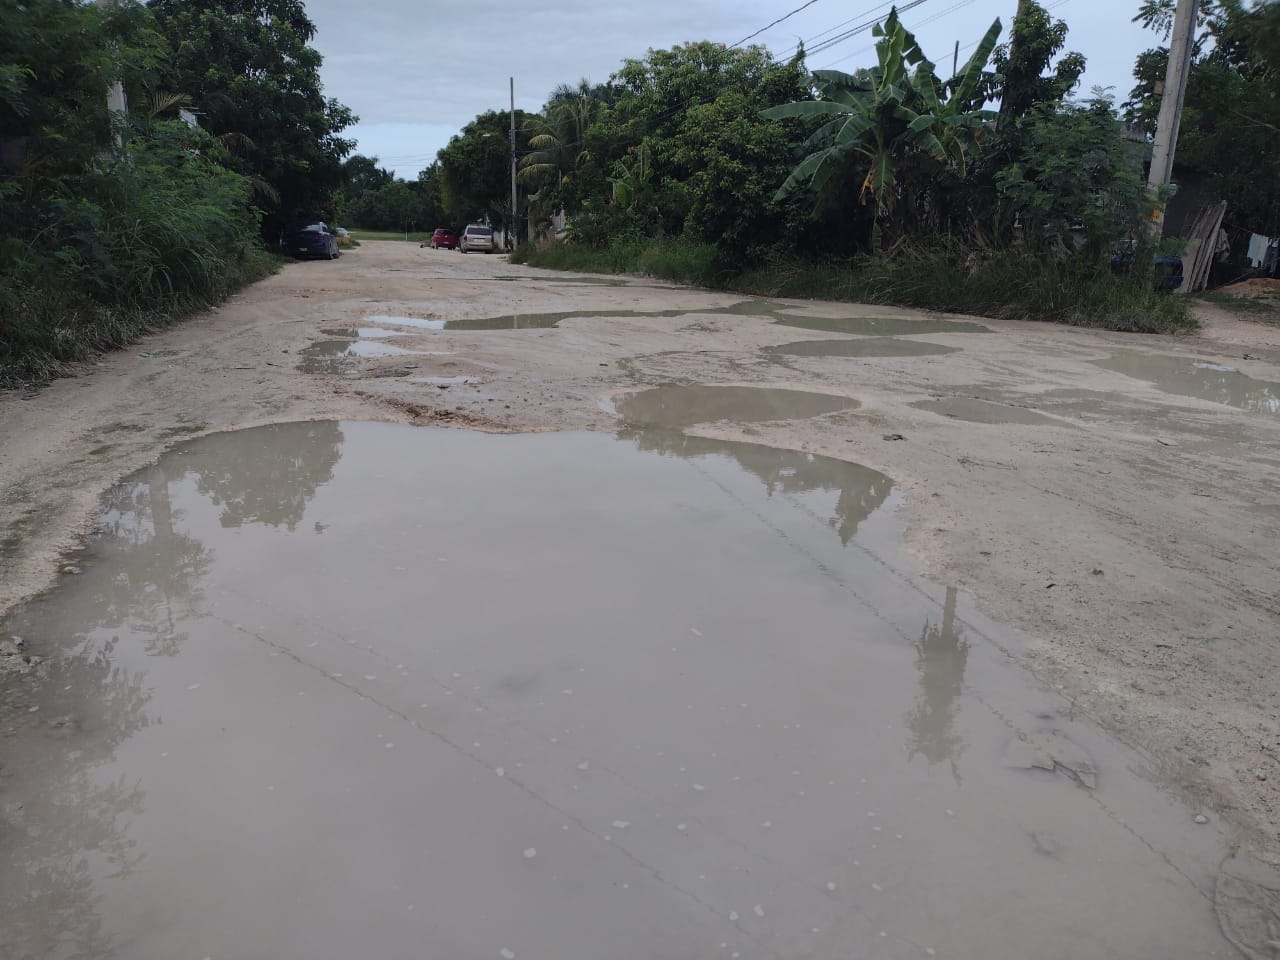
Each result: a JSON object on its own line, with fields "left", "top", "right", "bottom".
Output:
{"left": 0, "top": 0, "right": 353, "bottom": 387}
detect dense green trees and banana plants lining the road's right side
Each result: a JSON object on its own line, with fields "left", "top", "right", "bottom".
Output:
{"left": 348, "top": 0, "right": 1280, "bottom": 332}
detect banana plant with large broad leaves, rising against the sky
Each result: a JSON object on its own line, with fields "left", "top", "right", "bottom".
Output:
{"left": 763, "top": 8, "right": 1001, "bottom": 239}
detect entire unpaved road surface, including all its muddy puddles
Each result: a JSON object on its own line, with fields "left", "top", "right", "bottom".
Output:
{"left": 0, "top": 242, "right": 1280, "bottom": 960}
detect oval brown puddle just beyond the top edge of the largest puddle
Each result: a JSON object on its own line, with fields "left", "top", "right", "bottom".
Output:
{"left": 614, "top": 385, "right": 858, "bottom": 429}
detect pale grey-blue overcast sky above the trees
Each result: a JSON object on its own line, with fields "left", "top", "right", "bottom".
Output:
{"left": 306, "top": 0, "right": 1158, "bottom": 179}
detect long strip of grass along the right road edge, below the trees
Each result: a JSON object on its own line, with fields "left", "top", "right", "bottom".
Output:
{"left": 513, "top": 241, "right": 1198, "bottom": 333}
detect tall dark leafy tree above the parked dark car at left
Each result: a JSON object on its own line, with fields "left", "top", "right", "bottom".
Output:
{"left": 148, "top": 0, "right": 356, "bottom": 241}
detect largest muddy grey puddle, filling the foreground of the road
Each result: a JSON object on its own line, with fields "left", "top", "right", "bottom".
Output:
{"left": 0, "top": 424, "right": 1234, "bottom": 960}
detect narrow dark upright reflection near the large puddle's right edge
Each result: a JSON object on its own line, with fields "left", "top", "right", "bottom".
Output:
{"left": 906, "top": 586, "right": 969, "bottom": 782}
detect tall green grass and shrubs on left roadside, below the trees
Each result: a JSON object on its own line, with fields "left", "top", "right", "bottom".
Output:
{"left": 0, "top": 123, "right": 278, "bottom": 387}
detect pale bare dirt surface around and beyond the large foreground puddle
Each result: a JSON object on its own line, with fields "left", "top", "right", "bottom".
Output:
{"left": 0, "top": 242, "right": 1280, "bottom": 855}
